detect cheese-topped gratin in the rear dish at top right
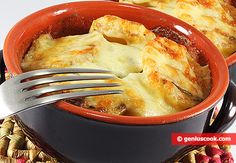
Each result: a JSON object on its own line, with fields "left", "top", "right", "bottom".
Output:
{"left": 120, "top": 0, "right": 236, "bottom": 57}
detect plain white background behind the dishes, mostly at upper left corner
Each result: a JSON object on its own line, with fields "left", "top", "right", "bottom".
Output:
{"left": 0, "top": 0, "right": 236, "bottom": 158}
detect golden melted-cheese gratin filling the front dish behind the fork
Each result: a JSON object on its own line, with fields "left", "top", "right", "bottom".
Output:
{"left": 22, "top": 15, "right": 210, "bottom": 116}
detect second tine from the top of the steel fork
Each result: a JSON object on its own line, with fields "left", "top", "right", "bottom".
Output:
{"left": 19, "top": 75, "right": 114, "bottom": 90}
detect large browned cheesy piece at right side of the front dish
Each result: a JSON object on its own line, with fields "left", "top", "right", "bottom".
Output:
{"left": 142, "top": 37, "right": 211, "bottom": 110}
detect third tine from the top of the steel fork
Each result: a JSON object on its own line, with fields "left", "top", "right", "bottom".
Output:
{"left": 24, "top": 83, "right": 120, "bottom": 99}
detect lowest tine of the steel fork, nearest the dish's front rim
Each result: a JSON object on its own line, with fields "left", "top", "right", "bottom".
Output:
{"left": 26, "top": 90, "right": 123, "bottom": 107}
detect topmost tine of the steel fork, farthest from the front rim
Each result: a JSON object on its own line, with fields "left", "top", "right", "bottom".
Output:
{"left": 17, "top": 68, "right": 110, "bottom": 81}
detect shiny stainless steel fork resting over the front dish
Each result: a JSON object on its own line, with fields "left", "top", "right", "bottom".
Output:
{"left": 0, "top": 68, "right": 122, "bottom": 119}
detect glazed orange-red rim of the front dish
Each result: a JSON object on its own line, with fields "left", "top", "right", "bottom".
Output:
{"left": 4, "top": 1, "right": 230, "bottom": 125}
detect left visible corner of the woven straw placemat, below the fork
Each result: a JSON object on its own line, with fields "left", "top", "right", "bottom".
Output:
{"left": 0, "top": 118, "right": 58, "bottom": 163}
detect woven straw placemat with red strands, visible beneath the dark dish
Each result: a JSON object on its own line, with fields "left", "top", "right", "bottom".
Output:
{"left": 0, "top": 117, "right": 234, "bottom": 163}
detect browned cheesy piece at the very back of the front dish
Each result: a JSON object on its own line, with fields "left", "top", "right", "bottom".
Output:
{"left": 90, "top": 15, "right": 156, "bottom": 48}
